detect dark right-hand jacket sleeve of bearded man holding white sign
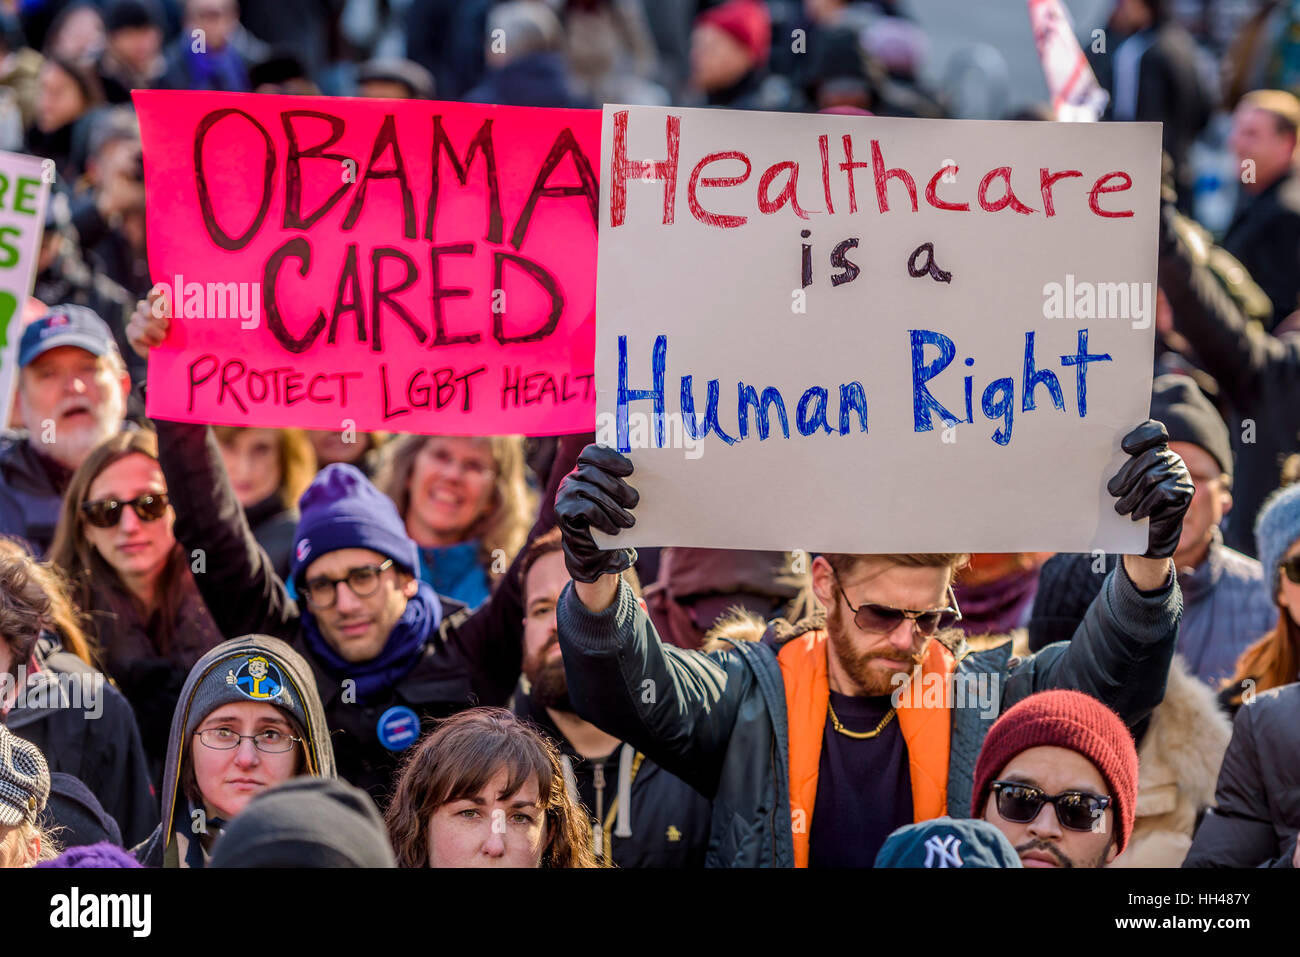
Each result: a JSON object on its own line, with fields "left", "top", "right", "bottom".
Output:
{"left": 1002, "top": 560, "right": 1183, "bottom": 728}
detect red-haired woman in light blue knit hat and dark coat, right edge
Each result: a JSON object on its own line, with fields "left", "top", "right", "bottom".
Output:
{"left": 1183, "top": 484, "right": 1300, "bottom": 867}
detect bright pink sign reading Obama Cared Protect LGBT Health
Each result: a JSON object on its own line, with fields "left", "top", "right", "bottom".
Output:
{"left": 134, "top": 91, "right": 601, "bottom": 434}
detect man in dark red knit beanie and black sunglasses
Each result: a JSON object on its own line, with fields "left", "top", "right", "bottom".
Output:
{"left": 971, "top": 690, "right": 1138, "bottom": 867}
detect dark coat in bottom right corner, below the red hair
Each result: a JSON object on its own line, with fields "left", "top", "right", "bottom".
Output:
{"left": 1183, "top": 684, "right": 1300, "bottom": 867}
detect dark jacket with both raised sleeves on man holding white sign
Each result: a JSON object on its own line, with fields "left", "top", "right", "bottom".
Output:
{"left": 556, "top": 566, "right": 1183, "bottom": 867}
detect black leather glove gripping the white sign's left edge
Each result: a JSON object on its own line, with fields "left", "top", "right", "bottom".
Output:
{"left": 555, "top": 445, "right": 641, "bottom": 583}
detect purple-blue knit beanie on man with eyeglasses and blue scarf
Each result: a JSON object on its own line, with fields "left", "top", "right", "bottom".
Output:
{"left": 289, "top": 463, "right": 420, "bottom": 581}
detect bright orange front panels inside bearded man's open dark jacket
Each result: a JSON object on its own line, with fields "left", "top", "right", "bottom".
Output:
{"left": 777, "top": 631, "right": 957, "bottom": 867}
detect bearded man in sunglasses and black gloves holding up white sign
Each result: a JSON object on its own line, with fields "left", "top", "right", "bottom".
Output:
{"left": 555, "top": 420, "right": 1192, "bottom": 867}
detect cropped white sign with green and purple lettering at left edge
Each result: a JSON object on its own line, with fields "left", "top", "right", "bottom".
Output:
{"left": 0, "top": 152, "right": 55, "bottom": 423}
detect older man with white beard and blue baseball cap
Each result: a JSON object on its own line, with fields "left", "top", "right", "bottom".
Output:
{"left": 0, "top": 304, "right": 131, "bottom": 558}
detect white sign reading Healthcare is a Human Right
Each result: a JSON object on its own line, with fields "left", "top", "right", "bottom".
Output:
{"left": 595, "top": 105, "right": 1161, "bottom": 554}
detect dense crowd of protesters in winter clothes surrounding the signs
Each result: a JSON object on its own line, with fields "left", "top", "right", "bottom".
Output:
{"left": 0, "top": 0, "right": 1300, "bottom": 867}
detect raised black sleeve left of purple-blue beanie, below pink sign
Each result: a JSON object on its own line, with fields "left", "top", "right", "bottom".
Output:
{"left": 156, "top": 420, "right": 299, "bottom": 641}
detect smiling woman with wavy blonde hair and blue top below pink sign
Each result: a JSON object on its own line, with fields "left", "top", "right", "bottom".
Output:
{"left": 374, "top": 436, "right": 537, "bottom": 609}
